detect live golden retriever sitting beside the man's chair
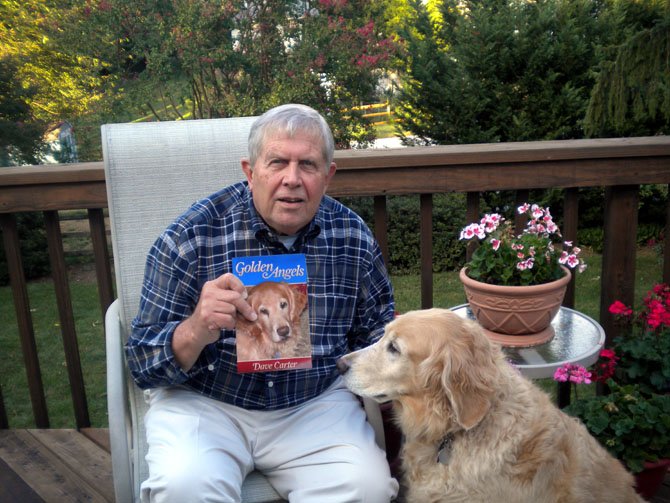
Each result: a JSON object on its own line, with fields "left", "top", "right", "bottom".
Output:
{"left": 338, "top": 309, "right": 642, "bottom": 503}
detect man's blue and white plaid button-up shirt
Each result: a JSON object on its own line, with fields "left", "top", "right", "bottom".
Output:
{"left": 126, "top": 182, "right": 394, "bottom": 409}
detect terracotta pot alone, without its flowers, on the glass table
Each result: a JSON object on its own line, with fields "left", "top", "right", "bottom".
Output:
{"left": 460, "top": 266, "right": 571, "bottom": 347}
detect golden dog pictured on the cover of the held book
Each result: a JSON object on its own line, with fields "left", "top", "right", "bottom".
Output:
{"left": 235, "top": 281, "right": 310, "bottom": 361}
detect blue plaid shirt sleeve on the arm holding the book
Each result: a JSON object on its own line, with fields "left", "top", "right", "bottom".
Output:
{"left": 125, "top": 232, "right": 198, "bottom": 388}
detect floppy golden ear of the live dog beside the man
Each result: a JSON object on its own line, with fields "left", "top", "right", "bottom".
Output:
{"left": 442, "top": 320, "right": 498, "bottom": 430}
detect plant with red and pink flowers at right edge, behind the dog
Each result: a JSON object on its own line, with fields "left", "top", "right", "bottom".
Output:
{"left": 554, "top": 292, "right": 670, "bottom": 499}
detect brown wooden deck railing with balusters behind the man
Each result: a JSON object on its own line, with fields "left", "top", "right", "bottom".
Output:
{"left": 0, "top": 137, "right": 670, "bottom": 428}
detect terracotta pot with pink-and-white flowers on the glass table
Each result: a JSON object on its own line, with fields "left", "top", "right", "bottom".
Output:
{"left": 460, "top": 203, "right": 586, "bottom": 346}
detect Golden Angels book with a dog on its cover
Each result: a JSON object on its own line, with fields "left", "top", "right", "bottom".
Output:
{"left": 233, "top": 254, "right": 312, "bottom": 373}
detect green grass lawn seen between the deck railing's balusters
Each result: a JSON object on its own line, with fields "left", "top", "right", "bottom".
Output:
{"left": 0, "top": 248, "right": 662, "bottom": 428}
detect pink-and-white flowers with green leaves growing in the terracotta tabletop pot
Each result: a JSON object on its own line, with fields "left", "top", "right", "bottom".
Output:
{"left": 460, "top": 203, "right": 586, "bottom": 286}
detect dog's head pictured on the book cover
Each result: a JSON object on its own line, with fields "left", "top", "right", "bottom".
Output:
{"left": 247, "top": 281, "right": 307, "bottom": 342}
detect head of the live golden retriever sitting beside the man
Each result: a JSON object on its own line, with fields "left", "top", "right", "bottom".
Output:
{"left": 338, "top": 309, "right": 499, "bottom": 430}
